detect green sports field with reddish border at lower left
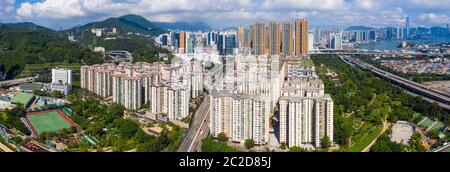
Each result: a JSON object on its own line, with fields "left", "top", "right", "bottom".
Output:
{"left": 26, "top": 110, "right": 77, "bottom": 137}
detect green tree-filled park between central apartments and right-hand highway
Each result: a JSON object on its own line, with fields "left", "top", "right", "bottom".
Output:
{"left": 312, "top": 55, "right": 450, "bottom": 152}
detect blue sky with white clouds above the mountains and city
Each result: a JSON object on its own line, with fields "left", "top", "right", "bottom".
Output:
{"left": 0, "top": 0, "right": 450, "bottom": 29}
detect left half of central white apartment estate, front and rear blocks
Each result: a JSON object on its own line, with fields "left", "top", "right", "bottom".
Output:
{"left": 210, "top": 55, "right": 283, "bottom": 145}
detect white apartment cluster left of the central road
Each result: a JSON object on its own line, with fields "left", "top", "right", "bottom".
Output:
{"left": 81, "top": 61, "right": 203, "bottom": 120}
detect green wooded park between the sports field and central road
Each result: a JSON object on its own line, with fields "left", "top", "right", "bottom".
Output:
{"left": 62, "top": 89, "right": 184, "bottom": 152}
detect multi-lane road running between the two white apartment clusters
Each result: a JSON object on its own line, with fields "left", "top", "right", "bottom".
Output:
{"left": 177, "top": 95, "right": 210, "bottom": 152}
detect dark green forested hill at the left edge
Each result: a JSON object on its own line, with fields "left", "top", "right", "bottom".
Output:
{"left": 0, "top": 24, "right": 103, "bottom": 79}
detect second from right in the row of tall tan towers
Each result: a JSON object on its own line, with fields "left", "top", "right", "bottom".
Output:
{"left": 281, "top": 23, "right": 294, "bottom": 55}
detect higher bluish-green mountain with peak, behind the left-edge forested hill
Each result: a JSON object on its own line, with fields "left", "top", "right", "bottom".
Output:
{"left": 62, "top": 15, "right": 171, "bottom": 62}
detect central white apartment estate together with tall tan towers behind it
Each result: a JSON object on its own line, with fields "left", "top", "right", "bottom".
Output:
{"left": 210, "top": 19, "right": 333, "bottom": 149}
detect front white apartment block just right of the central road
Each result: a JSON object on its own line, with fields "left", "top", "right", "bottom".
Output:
{"left": 210, "top": 91, "right": 272, "bottom": 145}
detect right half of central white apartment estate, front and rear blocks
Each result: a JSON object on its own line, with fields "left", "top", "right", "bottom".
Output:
{"left": 279, "top": 64, "right": 333, "bottom": 148}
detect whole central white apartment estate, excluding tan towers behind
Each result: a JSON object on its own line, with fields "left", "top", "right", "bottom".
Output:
{"left": 210, "top": 55, "right": 333, "bottom": 149}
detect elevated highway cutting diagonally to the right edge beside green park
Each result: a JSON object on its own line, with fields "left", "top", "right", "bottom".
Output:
{"left": 339, "top": 55, "right": 450, "bottom": 110}
